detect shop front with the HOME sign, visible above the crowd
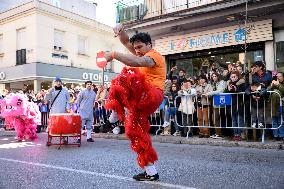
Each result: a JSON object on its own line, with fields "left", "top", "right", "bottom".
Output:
{"left": 155, "top": 20, "right": 274, "bottom": 76}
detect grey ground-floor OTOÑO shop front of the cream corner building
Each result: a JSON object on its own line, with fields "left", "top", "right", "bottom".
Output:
{"left": 0, "top": 63, "right": 116, "bottom": 93}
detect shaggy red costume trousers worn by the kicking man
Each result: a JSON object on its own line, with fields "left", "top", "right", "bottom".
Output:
{"left": 105, "top": 68, "right": 163, "bottom": 168}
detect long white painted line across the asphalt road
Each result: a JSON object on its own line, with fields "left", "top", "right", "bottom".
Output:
{"left": 0, "top": 158, "right": 196, "bottom": 189}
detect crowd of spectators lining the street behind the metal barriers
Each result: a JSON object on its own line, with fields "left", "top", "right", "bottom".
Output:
{"left": 0, "top": 61, "right": 284, "bottom": 141}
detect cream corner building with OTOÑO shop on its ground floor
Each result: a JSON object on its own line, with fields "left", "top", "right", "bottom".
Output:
{"left": 0, "top": 1, "right": 125, "bottom": 92}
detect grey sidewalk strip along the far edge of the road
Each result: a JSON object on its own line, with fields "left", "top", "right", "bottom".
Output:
{"left": 0, "top": 131, "right": 284, "bottom": 150}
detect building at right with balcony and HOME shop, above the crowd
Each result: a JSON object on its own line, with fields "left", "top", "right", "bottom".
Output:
{"left": 117, "top": 0, "right": 284, "bottom": 76}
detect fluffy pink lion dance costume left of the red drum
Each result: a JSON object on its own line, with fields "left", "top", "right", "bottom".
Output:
{"left": 0, "top": 93, "right": 41, "bottom": 141}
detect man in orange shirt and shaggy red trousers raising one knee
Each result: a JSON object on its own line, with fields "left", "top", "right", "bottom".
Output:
{"left": 105, "top": 24, "right": 166, "bottom": 181}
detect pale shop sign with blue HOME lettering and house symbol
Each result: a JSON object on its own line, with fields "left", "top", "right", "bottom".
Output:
{"left": 154, "top": 19, "right": 273, "bottom": 55}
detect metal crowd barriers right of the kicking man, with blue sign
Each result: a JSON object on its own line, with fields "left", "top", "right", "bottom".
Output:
{"left": 150, "top": 91, "right": 283, "bottom": 142}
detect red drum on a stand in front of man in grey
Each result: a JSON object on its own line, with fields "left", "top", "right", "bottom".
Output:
{"left": 48, "top": 113, "right": 82, "bottom": 135}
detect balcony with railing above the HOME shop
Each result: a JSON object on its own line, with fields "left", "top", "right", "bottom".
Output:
{"left": 116, "top": 0, "right": 225, "bottom": 23}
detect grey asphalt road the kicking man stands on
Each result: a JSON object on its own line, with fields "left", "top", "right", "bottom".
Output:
{"left": 0, "top": 134, "right": 284, "bottom": 189}
